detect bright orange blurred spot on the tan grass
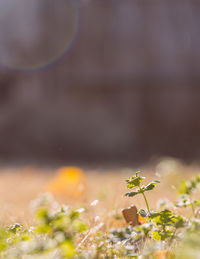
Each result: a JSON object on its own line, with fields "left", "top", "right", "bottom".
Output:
{"left": 47, "top": 167, "right": 85, "bottom": 198}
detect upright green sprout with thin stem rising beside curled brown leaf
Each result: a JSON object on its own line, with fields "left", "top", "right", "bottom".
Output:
{"left": 125, "top": 171, "right": 160, "bottom": 217}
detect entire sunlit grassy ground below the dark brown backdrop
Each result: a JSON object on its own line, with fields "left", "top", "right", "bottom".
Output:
{"left": 0, "top": 159, "right": 200, "bottom": 259}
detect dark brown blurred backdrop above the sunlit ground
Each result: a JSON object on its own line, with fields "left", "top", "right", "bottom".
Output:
{"left": 0, "top": 0, "right": 200, "bottom": 167}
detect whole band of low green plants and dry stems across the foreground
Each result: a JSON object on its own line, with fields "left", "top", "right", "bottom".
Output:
{"left": 0, "top": 172, "right": 200, "bottom": 259}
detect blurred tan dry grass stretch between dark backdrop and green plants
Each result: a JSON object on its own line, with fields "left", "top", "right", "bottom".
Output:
{"left": 0, "top": 167, "right": 198, "bottom": 227}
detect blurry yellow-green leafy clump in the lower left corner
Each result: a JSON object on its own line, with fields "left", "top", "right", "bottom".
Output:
{"left": 0, "top": 196, "right": 87, "bottom": 259}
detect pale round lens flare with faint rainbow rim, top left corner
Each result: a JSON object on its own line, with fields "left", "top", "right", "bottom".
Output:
{"left": 0, "top": 0, "right": 79, "bottom": 71}
